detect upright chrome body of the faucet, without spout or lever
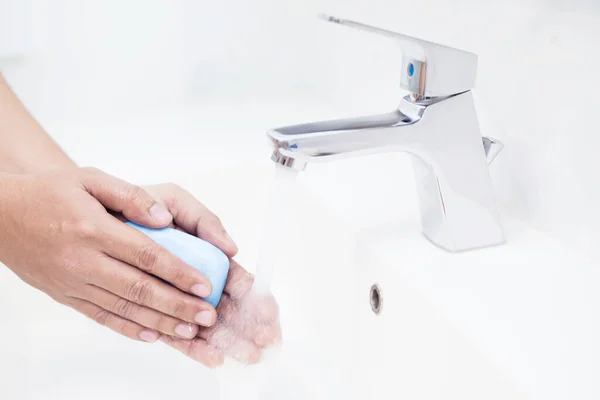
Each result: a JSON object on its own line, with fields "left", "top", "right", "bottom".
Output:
{"left": 413, "top": 92, "right": 505, "bottom": 252}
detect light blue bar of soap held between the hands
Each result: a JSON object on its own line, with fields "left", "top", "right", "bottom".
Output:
{"left": 126, "top": 222, "right": 229, "bottom": 307}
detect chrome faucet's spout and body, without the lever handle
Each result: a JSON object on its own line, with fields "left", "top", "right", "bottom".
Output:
{"left": 268, "top": 91, "right": 504, "bottom": 251}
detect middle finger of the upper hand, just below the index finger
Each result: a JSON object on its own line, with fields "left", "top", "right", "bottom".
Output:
{"left": 90, "top": 257, "right": 217, "bottom": 326}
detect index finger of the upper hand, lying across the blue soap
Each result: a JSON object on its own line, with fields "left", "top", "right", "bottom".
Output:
{"left": 102, "top": 220, "right": 212, "bottom": 297}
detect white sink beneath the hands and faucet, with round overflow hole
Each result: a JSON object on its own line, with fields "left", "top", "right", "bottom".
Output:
{"left": 0, "top": 151, "right": 600, "bottom": 400}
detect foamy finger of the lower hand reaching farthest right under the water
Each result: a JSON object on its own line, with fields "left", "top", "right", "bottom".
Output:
{"left": 217, "top": 293, "right": 281, "bottom": 348}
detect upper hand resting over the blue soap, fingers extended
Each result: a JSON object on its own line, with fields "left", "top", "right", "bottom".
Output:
{"left": 0, "top": 168, "right": 227, "bottom": 342}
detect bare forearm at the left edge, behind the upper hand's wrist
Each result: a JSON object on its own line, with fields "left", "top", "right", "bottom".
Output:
{"left": 0, "top": 74, "right": 75, "bottom": 173}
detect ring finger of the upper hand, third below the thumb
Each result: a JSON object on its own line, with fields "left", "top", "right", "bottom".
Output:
{"left": 76, "top": 285, "right": 198, "bottom": 339}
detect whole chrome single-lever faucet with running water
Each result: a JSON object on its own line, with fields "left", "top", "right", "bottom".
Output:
{"left": 268, "top": 16, "right": 505, "bottom": 252}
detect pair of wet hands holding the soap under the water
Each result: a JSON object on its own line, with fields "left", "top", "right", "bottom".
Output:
{"left": 0, "top": 168, "right": 281, "bottom": 367}
